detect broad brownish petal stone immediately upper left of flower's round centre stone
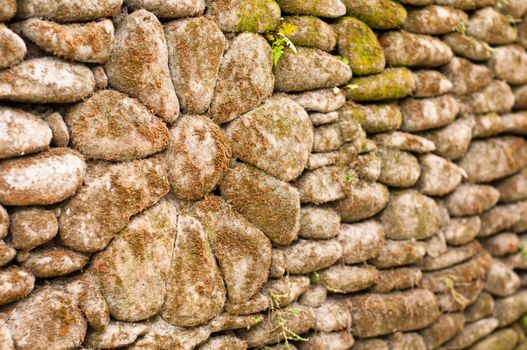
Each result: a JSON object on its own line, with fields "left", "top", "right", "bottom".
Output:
{"left": 65, "top": 90, "right": 168, "bottom": 161}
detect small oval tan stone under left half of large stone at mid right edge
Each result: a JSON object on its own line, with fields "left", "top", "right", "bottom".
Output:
{"left": 445, "top": 184, "right": 500, "bottom": 216}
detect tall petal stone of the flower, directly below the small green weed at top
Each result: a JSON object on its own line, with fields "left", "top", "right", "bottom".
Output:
{"left": 209, "top": 33, "right": 274, "bottom": 124}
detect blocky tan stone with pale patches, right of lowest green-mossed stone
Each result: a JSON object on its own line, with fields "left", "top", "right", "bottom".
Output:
{"left": 401, "top": 95, "right": 460, "bottom": 132}
